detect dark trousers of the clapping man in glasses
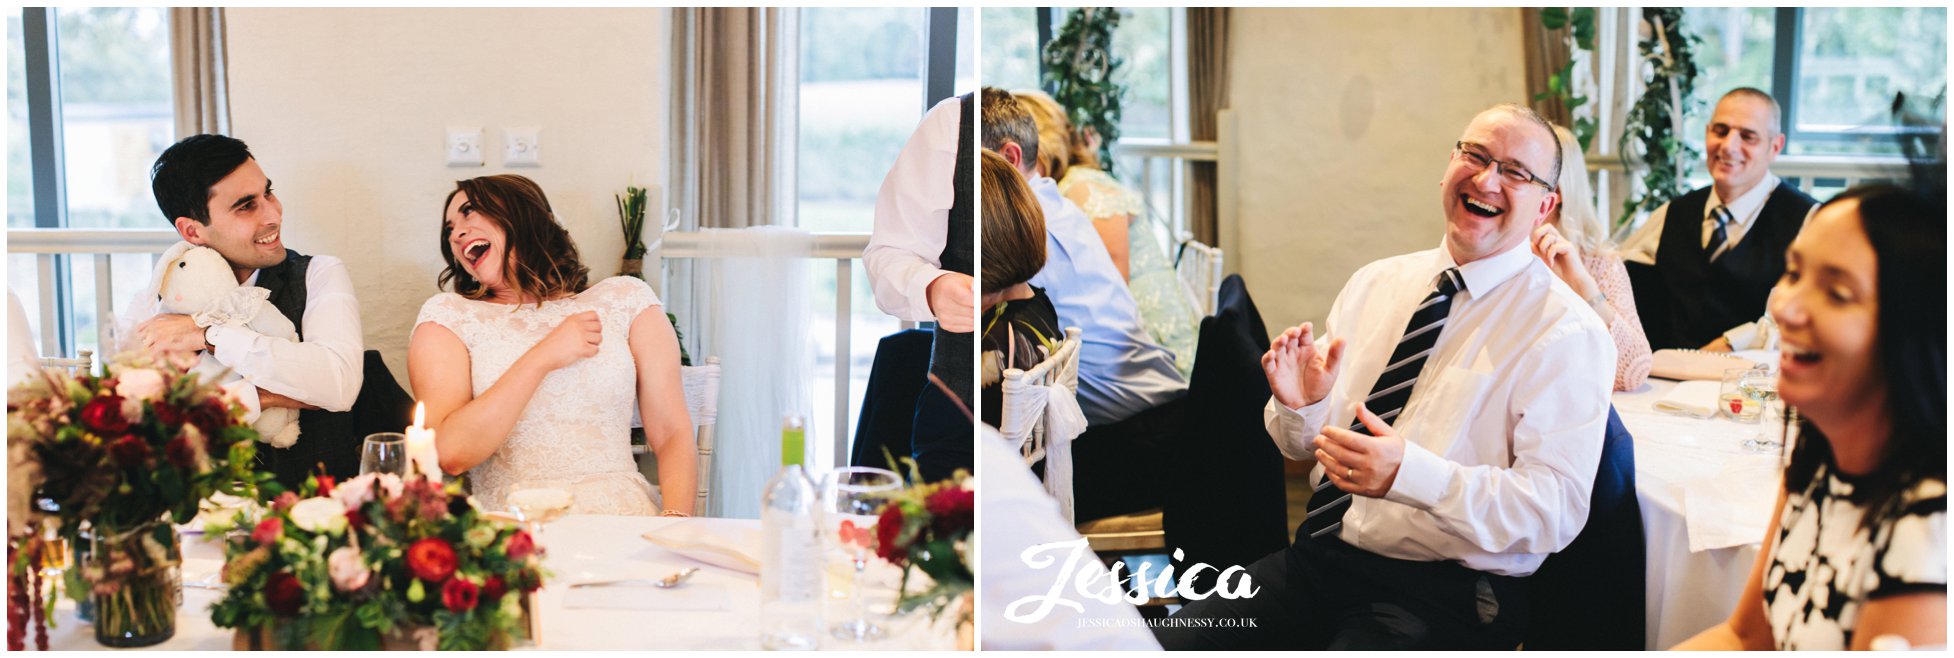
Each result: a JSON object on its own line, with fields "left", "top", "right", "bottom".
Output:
{"left": 1153, "top": 537, "right": 1526, "bottom": 650}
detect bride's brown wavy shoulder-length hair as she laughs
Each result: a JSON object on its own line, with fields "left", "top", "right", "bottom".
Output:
{"left": 438, "top": 174, "right": 590, "bottom": 301}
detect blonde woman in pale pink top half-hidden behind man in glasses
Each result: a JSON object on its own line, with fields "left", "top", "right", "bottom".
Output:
{"left": 1534, "top": 125, "right": 1653, "bottom": 391}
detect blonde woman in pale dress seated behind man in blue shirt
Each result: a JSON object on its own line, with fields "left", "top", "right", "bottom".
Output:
{"left": 1012, "top": 90, "right": 1202, "bottom": 377}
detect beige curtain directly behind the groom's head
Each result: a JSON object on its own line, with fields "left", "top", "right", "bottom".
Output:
{"left": 170, "top": 8, "right": 231, "bottom": 139}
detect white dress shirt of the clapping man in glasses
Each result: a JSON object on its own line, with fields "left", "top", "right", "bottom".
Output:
{"left": 1262, "top": 242, "right": 1614, "bottom": 576}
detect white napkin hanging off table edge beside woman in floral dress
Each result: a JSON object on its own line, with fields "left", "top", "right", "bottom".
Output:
{"left": 1682, "top": 455, "right": 1782, "bottom": 553}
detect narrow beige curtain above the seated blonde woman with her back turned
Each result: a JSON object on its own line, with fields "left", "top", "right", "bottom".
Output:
{"left": 1188, "top": 8, "right": 1229, "bottom": 244}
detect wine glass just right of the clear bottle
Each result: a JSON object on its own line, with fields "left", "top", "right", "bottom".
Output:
{"left": 821, "top": 467, "right": 903, "bottom": 642}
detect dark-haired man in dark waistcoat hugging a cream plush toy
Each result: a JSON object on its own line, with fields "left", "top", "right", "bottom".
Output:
{"left": 123, "top": 135, "right": 365, "bottom": 488}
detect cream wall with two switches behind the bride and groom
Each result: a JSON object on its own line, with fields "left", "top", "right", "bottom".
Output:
{"left": 225, "top": 8, "right": 670, "bottom": 387}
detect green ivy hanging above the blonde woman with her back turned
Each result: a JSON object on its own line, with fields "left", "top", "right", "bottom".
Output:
{"left": 1040, "top": 8, "right": 1126, "bottom": 174}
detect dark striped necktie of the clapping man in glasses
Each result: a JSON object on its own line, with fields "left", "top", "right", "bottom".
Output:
{"left": 1303, "top": 267, "right": 1466, "bottom": 539}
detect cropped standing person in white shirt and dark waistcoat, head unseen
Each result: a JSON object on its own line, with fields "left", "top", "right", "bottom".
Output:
{"left": 862, "top": 94, "right": 977, "bottom": 480}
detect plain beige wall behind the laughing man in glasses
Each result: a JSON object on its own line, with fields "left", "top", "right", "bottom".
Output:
{"left": 1223, "top": 8, "right": 1526, "bottom": 334}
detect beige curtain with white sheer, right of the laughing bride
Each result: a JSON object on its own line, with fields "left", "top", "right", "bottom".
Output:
{"left": 670, "top": 8, "right": 797, "bottom": 228}
